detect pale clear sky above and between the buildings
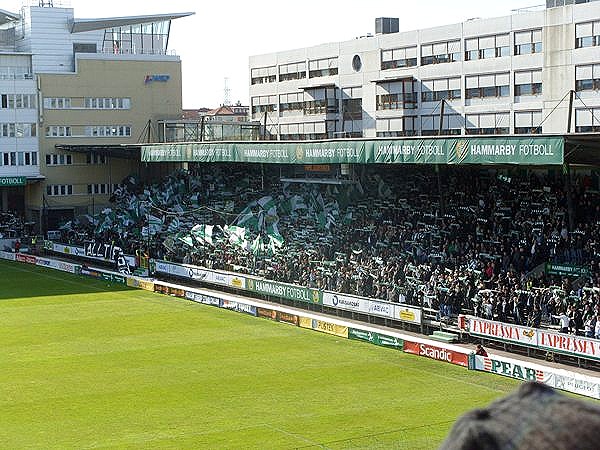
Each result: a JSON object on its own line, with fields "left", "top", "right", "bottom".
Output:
{"left": 0, "top": 0, "right": 544, "bottom": 109}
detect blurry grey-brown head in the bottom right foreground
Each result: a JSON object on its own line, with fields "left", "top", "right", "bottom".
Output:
{"left": 440, "top": 383, "right": 600, "bottom": 450}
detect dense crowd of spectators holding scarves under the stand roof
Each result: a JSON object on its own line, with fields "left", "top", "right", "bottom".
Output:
{"left": 57, "top": 166, "right": 600, "bottom": 337}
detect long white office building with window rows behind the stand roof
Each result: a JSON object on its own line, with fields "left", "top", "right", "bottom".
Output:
{"left": 249, "top": 0, "right": 600, "bottom": 140}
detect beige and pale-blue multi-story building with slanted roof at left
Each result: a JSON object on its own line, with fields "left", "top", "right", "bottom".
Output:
{"left": 0, "top": 2, "right": 190, "bottom": 229}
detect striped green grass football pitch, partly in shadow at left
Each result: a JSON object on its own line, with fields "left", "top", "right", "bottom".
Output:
{"left": 0, "top": 261, "right": 518, "bottom": 449}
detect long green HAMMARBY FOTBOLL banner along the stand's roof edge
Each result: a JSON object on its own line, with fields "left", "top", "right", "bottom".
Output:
{"left": 141, "top": 136, "right": 564, "bottom": 165}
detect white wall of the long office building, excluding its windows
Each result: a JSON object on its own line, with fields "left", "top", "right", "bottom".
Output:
{"left": 250, "top": 2, "right": 600, "bottom": 137}
